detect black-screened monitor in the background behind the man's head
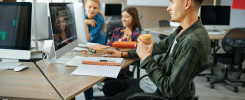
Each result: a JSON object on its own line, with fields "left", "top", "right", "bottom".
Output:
{"left": 200, "top": 5, "right": 231, "bottom": 30}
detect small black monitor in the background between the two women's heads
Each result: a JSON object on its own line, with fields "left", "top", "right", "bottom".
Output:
{"left": 102, "top": 3, "right": 124, "bottom": 16}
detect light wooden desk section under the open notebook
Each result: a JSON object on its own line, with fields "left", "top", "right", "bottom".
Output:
{"left": 37, "top": 51, "right": 137, "bottom": 99}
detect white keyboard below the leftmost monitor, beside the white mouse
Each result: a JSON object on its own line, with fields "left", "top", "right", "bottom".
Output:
{"left": 0, "top": 62, "right": 21, "bottom": 70}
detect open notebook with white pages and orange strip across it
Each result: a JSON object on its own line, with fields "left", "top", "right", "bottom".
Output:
{"left": 71, "top": 57, "right": 124, "bottom": 78}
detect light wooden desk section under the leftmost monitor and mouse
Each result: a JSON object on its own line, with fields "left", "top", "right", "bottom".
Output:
{"left": 0, "top": 63, "right": 61, "bottom": 99}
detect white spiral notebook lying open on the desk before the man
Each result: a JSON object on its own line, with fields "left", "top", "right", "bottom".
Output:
{"left": 71, "top": 57, "right": 124, "bottom": 78}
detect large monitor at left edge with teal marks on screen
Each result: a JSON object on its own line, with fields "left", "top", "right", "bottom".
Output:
{"left": 0, "top": 2, "right": 32, "bottom": 62}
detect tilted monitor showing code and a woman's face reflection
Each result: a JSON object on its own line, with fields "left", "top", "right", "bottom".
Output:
{"left": 49, "top": 3, "right": 78, "bottom": 61}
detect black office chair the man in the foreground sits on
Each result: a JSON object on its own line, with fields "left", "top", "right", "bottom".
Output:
{"left": 127, "top": 58, "right": 213, "bottom": 100}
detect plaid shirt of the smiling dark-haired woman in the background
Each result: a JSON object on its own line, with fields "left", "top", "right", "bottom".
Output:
{"left": 108, "top": 28, "right": 140, "bottom": 46}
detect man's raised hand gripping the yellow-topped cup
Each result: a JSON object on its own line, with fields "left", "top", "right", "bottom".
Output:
{"left": 136, "top": 38, "right": 153, "bottom": 60}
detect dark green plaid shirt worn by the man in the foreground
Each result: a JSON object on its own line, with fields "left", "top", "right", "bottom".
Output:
{"left": 128, "top": 19, "right": 211, "bottom": 98}
